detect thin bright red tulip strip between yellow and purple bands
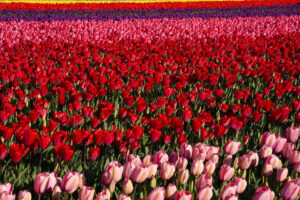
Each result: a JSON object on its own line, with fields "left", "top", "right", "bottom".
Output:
{"left": 0, "top": 0, "right": 299, "bottom": 10}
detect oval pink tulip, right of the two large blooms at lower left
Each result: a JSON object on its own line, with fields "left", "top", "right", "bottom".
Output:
{"left": 62, "top": 171, "right": 80, "bottom": 194}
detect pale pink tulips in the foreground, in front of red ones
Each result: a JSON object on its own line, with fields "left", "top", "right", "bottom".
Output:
{"left": 0, "top": 127, "right": 300, "bottom": 200}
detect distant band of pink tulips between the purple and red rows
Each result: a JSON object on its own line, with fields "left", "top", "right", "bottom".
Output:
{"left": 0, "top": 16, "right": 300, "bottom": 47}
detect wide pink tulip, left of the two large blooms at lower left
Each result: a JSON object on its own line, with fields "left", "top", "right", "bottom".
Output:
{"left": 34, "top": 172, "right": 57, "bottom": 194}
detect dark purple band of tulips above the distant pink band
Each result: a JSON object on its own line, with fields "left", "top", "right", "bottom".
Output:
{"left": 0, "top": 4, "right": 300, "bottom": 21}
